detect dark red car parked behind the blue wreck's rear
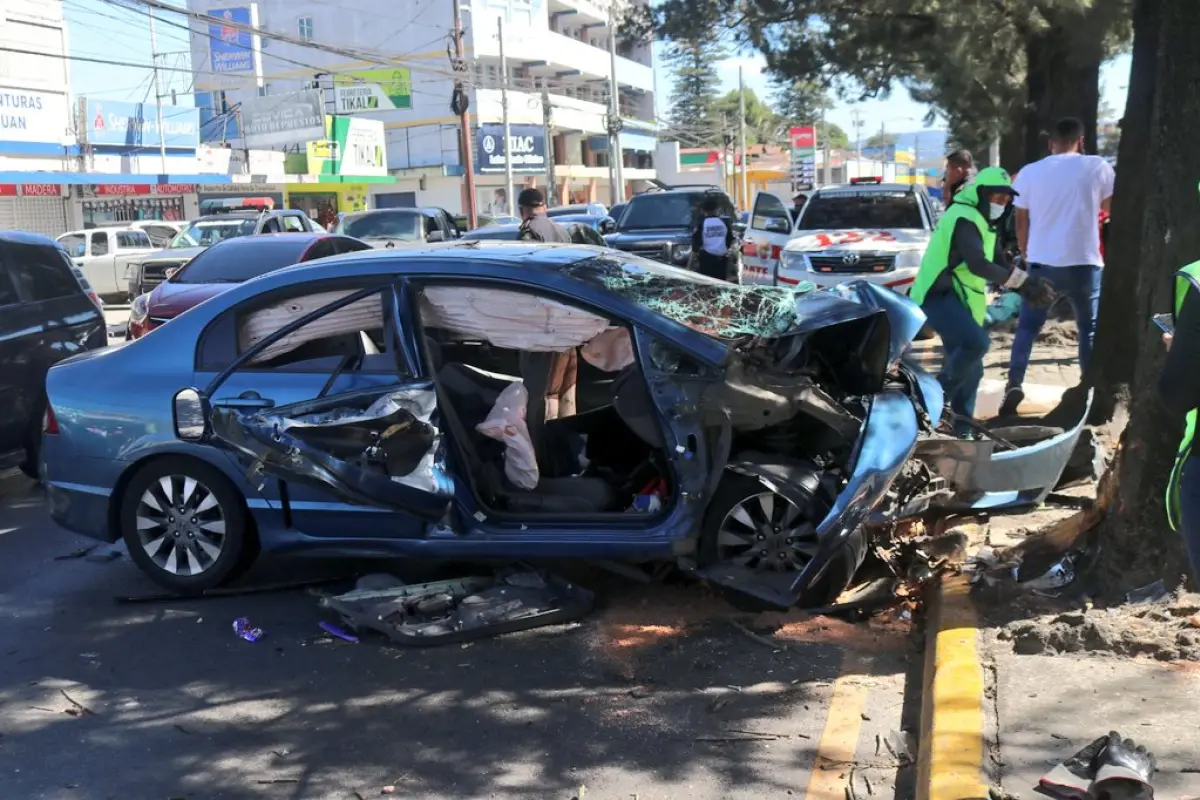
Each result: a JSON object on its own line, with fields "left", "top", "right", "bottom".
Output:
{"left": 126, "top": 233, "right": 371, "bottom": 339}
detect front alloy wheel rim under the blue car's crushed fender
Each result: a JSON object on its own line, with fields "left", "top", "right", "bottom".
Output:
{"left": 716, "top": 492, "right": 818, "bottom": 572}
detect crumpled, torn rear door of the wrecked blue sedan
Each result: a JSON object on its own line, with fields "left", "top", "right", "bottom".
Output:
{"left": 197, "top": 281, "right": 454, "bottom": 539}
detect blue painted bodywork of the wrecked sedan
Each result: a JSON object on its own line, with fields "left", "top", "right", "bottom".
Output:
{"left": 43, "top": 242, "right": 936, "bottom": 606}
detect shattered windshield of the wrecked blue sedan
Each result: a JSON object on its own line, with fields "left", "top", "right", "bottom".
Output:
{"left": 564, "top": 253, "right": 815, "bottom": 339}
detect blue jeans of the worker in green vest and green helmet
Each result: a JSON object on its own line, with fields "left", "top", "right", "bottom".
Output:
{"left": 922, "top": 291, "right": 991, "bottom": 417}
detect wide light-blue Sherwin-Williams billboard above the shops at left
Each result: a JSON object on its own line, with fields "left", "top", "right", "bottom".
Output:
{"left": 83, "top": 98, "right": 200, "bottom": 150}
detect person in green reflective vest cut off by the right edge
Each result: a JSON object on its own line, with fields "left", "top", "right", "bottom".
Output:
{"left": 1158, "top": 261, "right": 1200, "bottom": 581}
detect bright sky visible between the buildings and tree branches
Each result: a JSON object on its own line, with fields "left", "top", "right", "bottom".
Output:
{"left": 64, "top": 0, "right": 1129, "bottom": 138}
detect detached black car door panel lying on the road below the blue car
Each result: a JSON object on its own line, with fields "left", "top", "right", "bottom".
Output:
{"left": 320, "top": 570, "right": 594, "bottom": 646}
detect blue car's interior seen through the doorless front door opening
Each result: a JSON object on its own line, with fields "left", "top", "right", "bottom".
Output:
{"left": 418, "top": 287, "right": 670, "bottom": 515}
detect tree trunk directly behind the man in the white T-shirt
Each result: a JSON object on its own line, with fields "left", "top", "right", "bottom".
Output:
{"left": 1025, "top": 13, "right": 1104, "bottom": 163}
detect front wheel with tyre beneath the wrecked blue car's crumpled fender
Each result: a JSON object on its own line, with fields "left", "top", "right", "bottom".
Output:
{"left": 700, "top": 468, "right": 857, "bottom": 610}
